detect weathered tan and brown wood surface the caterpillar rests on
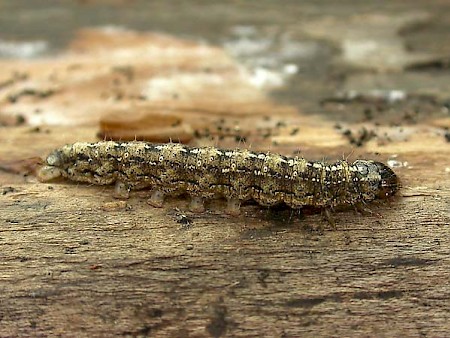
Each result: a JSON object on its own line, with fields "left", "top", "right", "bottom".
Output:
{"left": 0, "top": 5, "right": 450, "bottom": 337}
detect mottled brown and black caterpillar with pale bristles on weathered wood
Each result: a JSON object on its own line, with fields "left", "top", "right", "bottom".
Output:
{"left": 38, "top": 141, "right": 399, "bottom": 215}
